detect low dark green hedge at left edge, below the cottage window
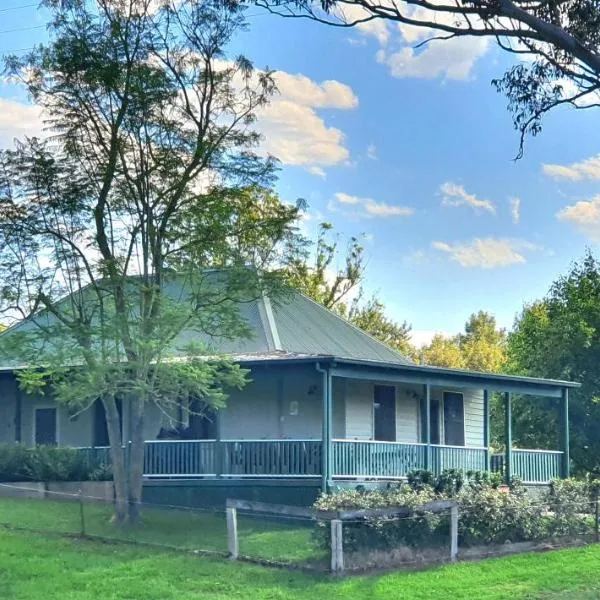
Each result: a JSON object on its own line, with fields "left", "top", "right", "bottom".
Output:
{"left": 0, "top": 444, "right": 112, "bottom": 482}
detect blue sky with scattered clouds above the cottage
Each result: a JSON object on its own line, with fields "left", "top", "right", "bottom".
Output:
{"left": 0, "top": 0, "right": 600, "bottom": 342}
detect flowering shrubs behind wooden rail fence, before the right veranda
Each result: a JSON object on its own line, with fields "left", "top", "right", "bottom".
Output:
{"left": 315, "top": 470, "right": 597, "bottom": 550}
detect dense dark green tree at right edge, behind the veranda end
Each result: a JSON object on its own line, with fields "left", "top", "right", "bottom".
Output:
{"left": 508, "top": 252, "right": 600, "bottom": 471}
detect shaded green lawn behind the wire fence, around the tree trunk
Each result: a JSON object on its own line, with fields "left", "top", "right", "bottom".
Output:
{"left": 0, "top": 498, "right": 325, "bottom": 564}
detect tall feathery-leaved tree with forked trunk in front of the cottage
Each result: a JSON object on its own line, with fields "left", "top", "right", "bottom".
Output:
{"left": 0, "top": 0, "right": 297, "bottom": 522}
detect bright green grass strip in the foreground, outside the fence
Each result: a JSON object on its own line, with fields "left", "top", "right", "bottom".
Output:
{"left": 0, "top": 530, "right": 600, "bottom": 600}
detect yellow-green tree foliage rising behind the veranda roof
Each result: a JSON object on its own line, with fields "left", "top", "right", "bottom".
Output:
{"left": 421, "top": 311, "right": 506, "bottom": 373}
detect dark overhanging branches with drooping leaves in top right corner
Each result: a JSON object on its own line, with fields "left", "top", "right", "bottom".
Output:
{"left": 262, "top": 0, "right": 600, "bottom": 154}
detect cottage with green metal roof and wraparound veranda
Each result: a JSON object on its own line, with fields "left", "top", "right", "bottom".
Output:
{"left": 0, "top": 286, "right": 577, "bottom": 502}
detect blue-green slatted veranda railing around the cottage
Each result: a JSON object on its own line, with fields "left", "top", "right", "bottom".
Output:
{"left": 79, "top": 439, "right": 562, "bottom": 483}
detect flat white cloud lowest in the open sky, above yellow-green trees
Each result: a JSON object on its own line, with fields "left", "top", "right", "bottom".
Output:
{"left": 431, "top": 238, "right": 541, "bottom": 269}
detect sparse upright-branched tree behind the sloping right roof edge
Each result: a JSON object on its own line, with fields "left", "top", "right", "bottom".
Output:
{"left": 286, "top": 223, "right": 414, "bottom": 356}
